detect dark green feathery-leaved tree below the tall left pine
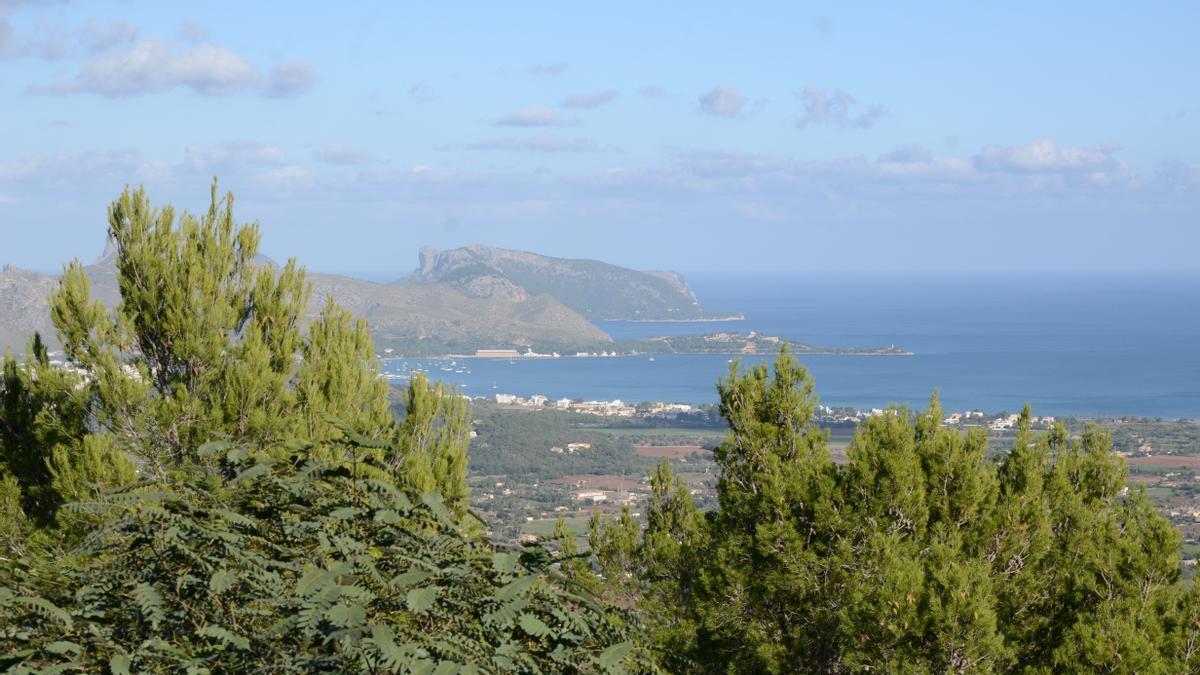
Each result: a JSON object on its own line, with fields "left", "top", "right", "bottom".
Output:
{"left": 0, "top": 438, "right": 637, "bottom": 673}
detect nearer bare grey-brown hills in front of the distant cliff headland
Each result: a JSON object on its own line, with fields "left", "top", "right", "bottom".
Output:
{"left": 0, "top": 251, "right": 611, "bottom": 356}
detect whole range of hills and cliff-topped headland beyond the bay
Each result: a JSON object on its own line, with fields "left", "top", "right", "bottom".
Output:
{"left": 0, "top": 246, "right": 720, "bottom": 356}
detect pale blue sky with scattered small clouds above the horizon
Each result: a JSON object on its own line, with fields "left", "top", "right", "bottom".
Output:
{"left": 0, "top": 0, "right": 1200, "bottom": 277}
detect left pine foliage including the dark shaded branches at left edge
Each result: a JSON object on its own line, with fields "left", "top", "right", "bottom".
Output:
{"left": 0, "top": 183, "right": 408, "bottom": 554}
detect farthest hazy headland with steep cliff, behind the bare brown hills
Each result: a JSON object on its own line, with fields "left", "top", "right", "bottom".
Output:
{"left": 412, "top": 245, "right": 710, "bottom": 321}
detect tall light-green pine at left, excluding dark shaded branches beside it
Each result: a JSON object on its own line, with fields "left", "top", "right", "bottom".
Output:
{"left": 43, "top": 183, "right": 386, "bottom": 473}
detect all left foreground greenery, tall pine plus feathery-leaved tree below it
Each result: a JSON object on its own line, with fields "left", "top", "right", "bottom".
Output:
{"left": 0, "top": 181, "right": 649, "bottom": 673}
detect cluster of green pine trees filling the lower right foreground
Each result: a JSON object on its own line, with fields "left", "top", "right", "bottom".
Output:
{"left": 593, "top": 350, "right": 1200, "bottom": 673}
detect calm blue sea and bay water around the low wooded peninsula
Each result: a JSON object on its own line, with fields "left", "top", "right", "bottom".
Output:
{"left": 384, "top": 273, "right": 1200, "bottom": 419}
